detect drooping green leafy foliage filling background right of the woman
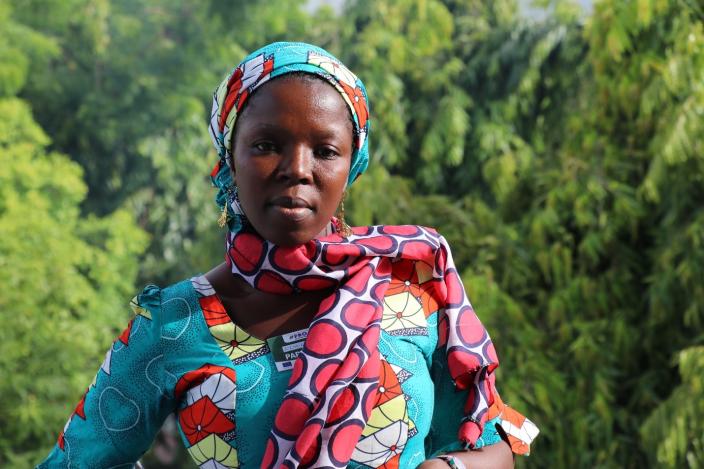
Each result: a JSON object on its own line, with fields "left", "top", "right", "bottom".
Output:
{"left": 349, "top": 1, "right": 704, "bottom": 467}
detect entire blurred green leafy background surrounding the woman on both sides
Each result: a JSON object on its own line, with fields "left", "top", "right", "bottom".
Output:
{"left": 0, "top": 0, "right": 704, "bottom": 468}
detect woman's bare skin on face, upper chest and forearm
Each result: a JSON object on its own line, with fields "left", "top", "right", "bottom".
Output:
{"left": 205, "top": 76, "right": 513, "bottom": 469}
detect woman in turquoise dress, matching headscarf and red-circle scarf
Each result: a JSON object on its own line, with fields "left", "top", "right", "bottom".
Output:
{"left": 41, "top": 43, "right": 537, "bottom": 468}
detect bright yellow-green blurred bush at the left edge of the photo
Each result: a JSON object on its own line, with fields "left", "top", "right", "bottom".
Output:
{"left": 0, "top": 98, "right": 146, "bottom": 467}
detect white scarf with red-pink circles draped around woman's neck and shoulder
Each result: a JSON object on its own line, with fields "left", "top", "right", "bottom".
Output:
{"left": 224, "top": 226, "right": 498, "bottom": 468}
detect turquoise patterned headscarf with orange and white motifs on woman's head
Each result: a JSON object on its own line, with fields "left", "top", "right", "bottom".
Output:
{"left": 210, "top": 42, "right": 369, "bottom": 231}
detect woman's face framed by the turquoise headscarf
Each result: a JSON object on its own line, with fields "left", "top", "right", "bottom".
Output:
{"left": 233, "top": 76, "right": 353, "bottom": 246}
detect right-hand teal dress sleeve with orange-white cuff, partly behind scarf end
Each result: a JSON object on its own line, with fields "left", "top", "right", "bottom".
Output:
{"left": 426, "top": 332, "right": 539, "bottom": 457}
